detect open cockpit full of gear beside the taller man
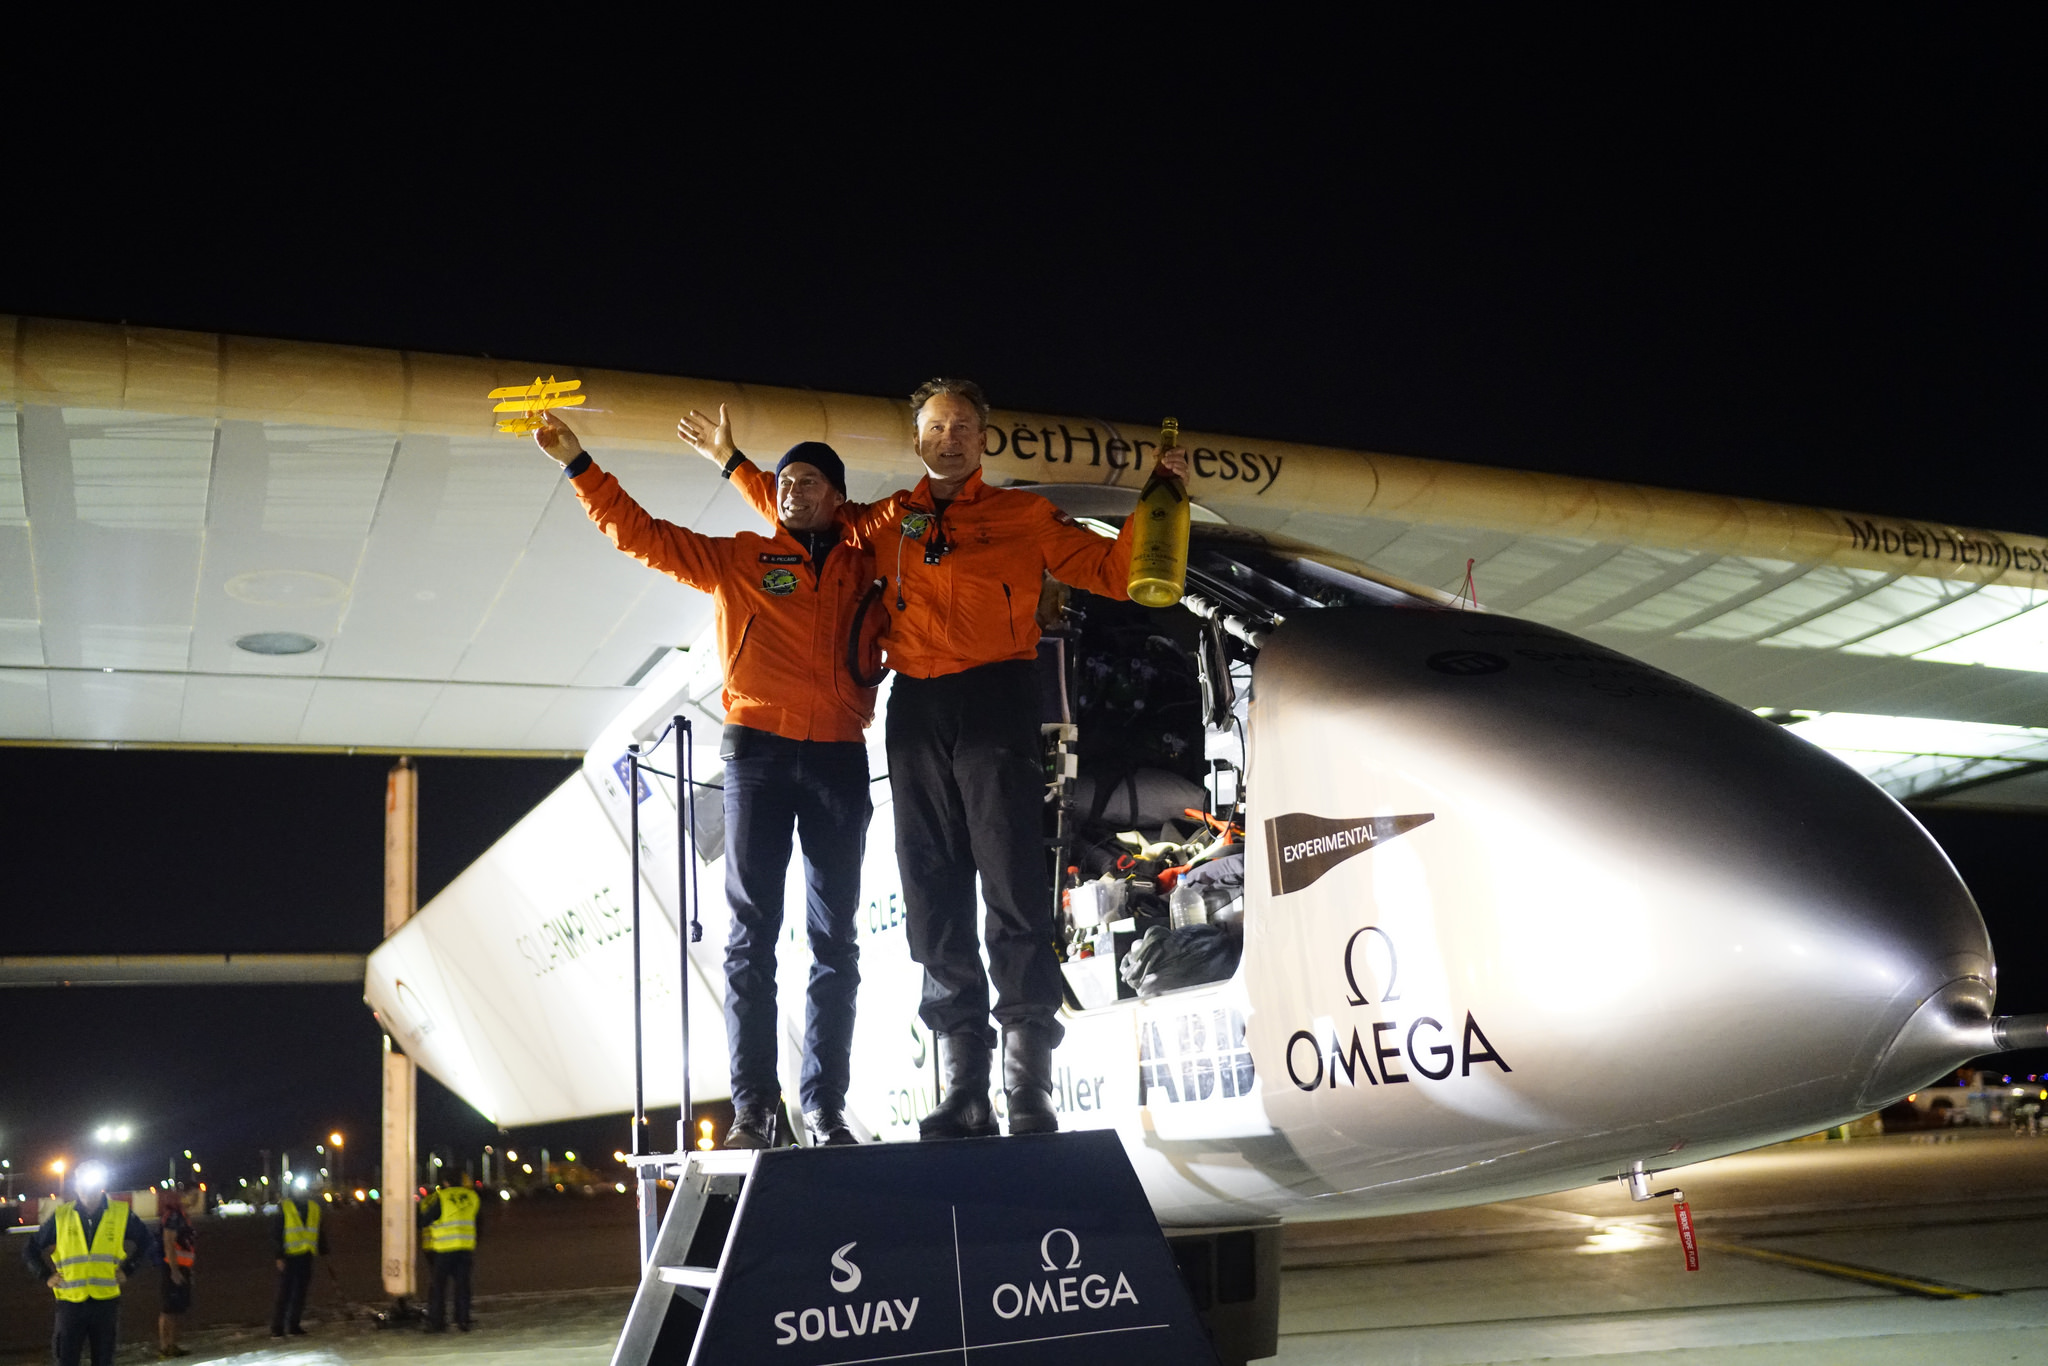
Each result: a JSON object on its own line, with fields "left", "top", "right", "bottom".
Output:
{"left": 1040, "top": 526, "right": 1440, "bottom": 1010}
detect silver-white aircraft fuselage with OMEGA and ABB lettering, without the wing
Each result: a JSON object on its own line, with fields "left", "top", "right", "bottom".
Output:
{"left": 356, "top": 505, "right": 2038, "bottom": 1225}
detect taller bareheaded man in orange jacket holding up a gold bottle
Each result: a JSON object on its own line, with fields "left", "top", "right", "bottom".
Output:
{"left": 678, "top": 379, "right": 1188, "bottom": 1139}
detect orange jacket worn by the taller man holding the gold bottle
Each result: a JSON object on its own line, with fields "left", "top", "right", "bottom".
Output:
{"left": 731, "top": 461, "right": 1137, "bottom": 678}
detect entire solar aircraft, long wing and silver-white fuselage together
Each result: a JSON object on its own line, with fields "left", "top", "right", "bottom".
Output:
{"left": 0, "top": 315, "right": 2048, "bottom": 1356}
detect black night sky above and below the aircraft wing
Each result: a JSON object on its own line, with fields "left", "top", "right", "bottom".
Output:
{"left": 0, "top": 26, "right": 2048, "bottom": 1176}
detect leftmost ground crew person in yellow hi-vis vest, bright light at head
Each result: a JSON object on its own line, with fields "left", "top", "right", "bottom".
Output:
{"left": 20, "top": 1161, "right": 150, "bottom": 1366}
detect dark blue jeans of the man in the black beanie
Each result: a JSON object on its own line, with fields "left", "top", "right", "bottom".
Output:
{"left": 725, "top": 727, "right": 874, "bottom": 1110}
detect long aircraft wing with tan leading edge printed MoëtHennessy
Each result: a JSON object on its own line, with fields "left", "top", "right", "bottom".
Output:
{"left": 0, "top": 317, "right": 2048, "bottom": 809}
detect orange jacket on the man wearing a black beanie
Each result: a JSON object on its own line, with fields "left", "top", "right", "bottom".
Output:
{"left": 569, "top": 465, "right": 881, "bottom": 739}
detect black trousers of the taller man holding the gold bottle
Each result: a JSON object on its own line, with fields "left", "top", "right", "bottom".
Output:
{"left": 889, "top": 659, "right": 1065, "bottom": 1047}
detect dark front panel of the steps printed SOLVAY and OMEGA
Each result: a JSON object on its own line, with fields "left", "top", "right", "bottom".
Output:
{"left": 690, "top": 1133, "right": 1214, "bottom": 1366}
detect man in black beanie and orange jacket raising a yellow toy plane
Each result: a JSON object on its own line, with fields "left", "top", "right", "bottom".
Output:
{"left": 535, "top": 416, "right": 881, "bottom": 1147}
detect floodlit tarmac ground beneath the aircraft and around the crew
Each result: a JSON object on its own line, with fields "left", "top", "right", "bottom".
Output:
{"left": 0, "top": 1135, "right": 2048, "bottom": 1366}
